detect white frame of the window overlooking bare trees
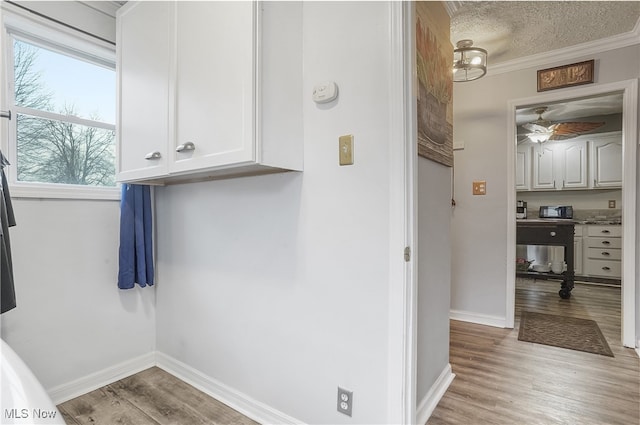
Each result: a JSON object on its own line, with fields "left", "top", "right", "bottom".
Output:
{"left": 0, "top": 2, "right": 121, "bottom": 200}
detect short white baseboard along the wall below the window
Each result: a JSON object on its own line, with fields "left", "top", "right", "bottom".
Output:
{"left": 47, "top": 352, "right": 156, "bottom": 405}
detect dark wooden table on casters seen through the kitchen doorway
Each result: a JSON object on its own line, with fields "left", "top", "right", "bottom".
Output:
{"left": 516, "top": 219, "right": 575, "bottom": 299}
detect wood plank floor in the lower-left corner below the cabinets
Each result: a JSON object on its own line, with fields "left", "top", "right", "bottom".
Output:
{"left": 58, "top": 367, "right": 257, "bottom": 425}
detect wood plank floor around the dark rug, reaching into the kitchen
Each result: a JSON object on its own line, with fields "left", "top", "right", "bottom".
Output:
{"left": 427, "top": 279, "right": 640, "bottom": 425}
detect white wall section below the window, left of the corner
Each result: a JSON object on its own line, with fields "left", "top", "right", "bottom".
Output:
{"left": 1, "top": 199, "right": 155, "bottom": 390}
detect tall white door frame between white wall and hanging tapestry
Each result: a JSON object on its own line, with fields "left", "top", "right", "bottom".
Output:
{"left": 387, "top": 2, "right": 418, "bottom": 424}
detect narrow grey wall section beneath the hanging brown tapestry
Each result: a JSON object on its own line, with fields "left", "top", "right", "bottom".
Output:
{"left": 417, "top": 157, "right": 452, "bottom": 402}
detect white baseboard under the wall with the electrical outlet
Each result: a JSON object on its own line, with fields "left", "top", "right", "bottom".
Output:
{"left": 156, "top": 352, "right": 303, "bottom": 425}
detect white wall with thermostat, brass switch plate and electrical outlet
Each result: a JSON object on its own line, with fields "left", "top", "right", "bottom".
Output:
{"left": 157, "top": 2, "right": 401, "bottom": 424}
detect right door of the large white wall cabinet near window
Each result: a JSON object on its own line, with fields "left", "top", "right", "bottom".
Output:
{"left": 174, "top": 1, "right": 257, "bottom": 173}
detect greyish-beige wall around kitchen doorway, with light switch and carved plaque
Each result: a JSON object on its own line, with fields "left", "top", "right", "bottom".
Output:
{"left": 451, "top": 45, "right": 640, "bottom": 323}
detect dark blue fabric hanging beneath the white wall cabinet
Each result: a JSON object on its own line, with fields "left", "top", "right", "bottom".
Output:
{"left": 118, "top": 184, "right": 154, "bottom": 289}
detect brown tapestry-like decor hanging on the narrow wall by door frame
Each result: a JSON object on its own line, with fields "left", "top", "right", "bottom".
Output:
{"left": 415, "top": 1, "right": 453, "bottom": 167}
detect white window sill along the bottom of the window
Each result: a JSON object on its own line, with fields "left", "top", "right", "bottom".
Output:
{"left": 9, "top": 183, "right": 121, "bottom": 201}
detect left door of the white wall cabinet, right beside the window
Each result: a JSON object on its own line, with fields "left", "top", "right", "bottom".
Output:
{"left": 117, "top": 2, "right": 170, "bottom": 181}
